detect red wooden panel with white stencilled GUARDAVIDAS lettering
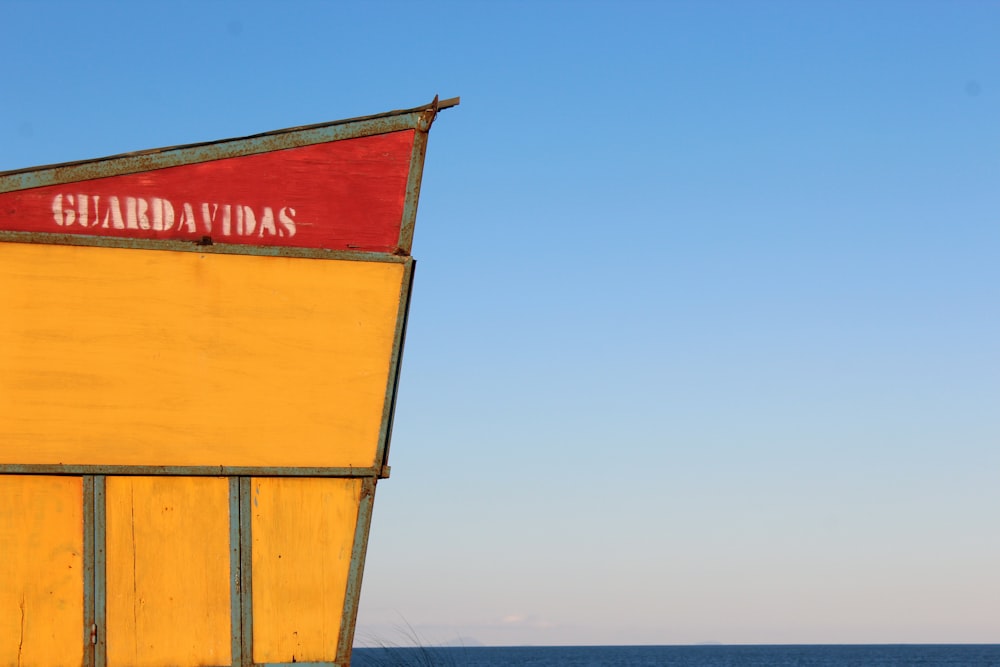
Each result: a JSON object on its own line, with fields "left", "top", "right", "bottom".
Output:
{"left": 0, "top": 130, "right": 415, "bottom": 252}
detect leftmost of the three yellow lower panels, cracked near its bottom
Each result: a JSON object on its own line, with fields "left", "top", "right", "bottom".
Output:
{"left": 0, "top": 475, "right": 84, "bottom": 667}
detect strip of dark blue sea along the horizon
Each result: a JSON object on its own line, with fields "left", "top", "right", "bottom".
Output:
{"left": 352, "top": 644, "right": 1000, "bottom": 667}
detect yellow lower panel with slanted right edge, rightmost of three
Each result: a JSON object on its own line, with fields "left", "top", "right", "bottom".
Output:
{"left": 251, "top": 478, "right": 362, "bottom": 663}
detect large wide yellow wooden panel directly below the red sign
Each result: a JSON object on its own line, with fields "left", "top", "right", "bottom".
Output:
{"left": 0, "top": 243, "right": 405, "bottom": 468}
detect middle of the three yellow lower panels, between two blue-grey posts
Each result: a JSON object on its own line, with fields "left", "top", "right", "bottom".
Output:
{"left": 106, "top": 477, "right": 232, "bottom": 667}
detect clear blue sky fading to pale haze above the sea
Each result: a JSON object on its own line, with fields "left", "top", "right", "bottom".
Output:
{"left": 0, "top": 0, "right": 1000, "bottom": 644}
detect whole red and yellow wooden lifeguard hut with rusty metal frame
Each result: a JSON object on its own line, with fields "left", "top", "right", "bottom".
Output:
{"left": 0, "top": 98, "right": 458, "bottom": 667}
